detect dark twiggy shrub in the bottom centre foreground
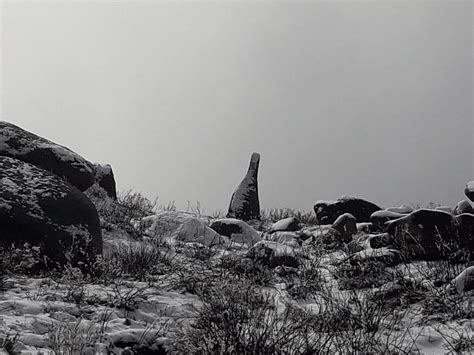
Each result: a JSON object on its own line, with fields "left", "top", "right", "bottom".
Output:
{"left": 176, "top": 282, "right": 330, "bottom": 354}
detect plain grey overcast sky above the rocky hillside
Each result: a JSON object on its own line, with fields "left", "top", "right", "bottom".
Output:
{"left": 1, "top": 0, "right": 474, "bottom": 213}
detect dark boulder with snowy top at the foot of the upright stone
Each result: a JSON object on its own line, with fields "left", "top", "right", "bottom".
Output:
{"left": 210, "top": 218, "right": 262, "bottom": 245}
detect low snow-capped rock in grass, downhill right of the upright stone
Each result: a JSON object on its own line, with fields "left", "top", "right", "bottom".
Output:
{"left": 247, "top": 240, "right": 299, "bottom": 268}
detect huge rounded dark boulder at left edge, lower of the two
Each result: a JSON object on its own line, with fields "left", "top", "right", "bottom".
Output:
{"left": 0, "top": 156, "right": 102, "bottom": 265}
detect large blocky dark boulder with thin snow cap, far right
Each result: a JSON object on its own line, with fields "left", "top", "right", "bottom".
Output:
{"left": 387, "top": 209, "right": 460, "bottom": 259}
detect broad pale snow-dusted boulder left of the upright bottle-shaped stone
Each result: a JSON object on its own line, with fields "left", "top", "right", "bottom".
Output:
{"left": 142, "top": 211, "right": 227, "bottom": 246}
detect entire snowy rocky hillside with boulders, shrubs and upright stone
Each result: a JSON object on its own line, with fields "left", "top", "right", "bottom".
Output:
{"left": 0, "top": 122, "right": 474, "bottom": 354}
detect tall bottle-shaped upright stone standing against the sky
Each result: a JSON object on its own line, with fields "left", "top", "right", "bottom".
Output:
{"left": 227, "top": 153, "right": 260, "bottom": 221}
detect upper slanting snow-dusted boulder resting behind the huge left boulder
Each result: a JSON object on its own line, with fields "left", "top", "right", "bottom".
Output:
{"left": 0, "top": 121, "right": 95, "bottom": 191}
